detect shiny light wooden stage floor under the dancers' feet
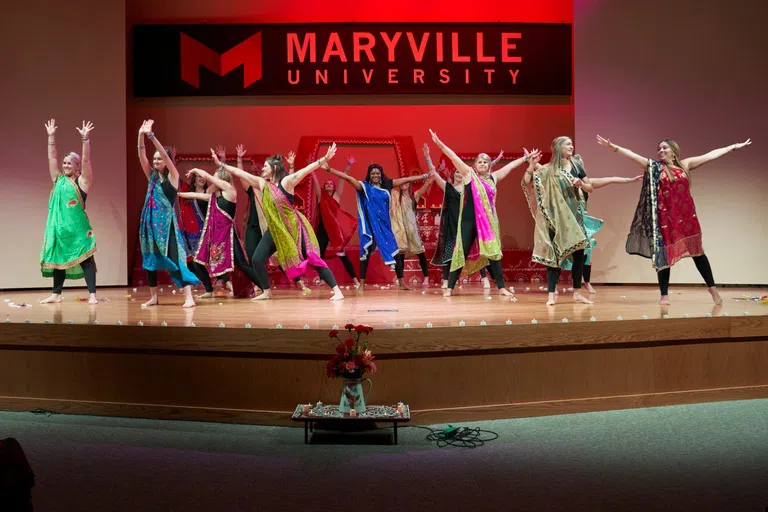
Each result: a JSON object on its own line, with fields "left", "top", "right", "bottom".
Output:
{"left": 0, "top": 284, "right": 768, "bottom": 330}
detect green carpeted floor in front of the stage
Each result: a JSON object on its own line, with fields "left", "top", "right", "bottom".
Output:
{"left": 0, "top": 400, "right": 768, "bottom": 512}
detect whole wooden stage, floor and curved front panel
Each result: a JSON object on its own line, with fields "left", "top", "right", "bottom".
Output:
{"left": 0, "top": 283, "right": 768, "bottom": 424}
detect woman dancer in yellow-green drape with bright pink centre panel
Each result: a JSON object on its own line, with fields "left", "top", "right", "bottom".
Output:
{"left": 429, "top": 130, "right": 538, "bottom": 297}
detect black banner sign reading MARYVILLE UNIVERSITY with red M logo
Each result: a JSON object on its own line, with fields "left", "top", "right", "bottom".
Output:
{"left": 132, "top": 23, "right": 572, "bottom": 97}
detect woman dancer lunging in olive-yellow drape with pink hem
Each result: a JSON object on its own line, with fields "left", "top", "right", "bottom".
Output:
{"left": 211, "top": 144, "right": 344, "bottom": 300}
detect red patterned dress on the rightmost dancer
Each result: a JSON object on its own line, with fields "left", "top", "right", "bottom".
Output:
{"left": 658, "top": 167, "right": 704, "bottom": 267}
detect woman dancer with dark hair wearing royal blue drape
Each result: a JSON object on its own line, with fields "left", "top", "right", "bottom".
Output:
{"left": 328, "top": 164, "right": 429, "bottom": 290}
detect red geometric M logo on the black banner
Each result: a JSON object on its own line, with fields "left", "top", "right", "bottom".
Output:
{"left": 180, "top": 32, "right": 261, "bottom": 88}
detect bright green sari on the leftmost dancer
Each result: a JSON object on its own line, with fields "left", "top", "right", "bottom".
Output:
{"left": 40, "top": 174, "right": 96, "bottom": 279}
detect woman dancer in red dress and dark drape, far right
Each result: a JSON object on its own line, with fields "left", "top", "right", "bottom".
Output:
{"left": 597, "top": 135, "right": 752, "bottom": 305}
